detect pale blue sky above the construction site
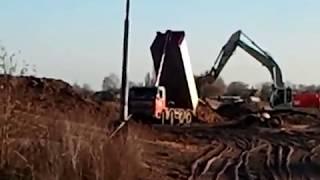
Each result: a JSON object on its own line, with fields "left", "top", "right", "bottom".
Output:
{"left": 0, "top": 0, "right": 320, "bottom": 89}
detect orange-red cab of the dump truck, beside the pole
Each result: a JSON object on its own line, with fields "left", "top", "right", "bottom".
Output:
{"left": 129, "top": 86, "right": 167, "bottom": 119}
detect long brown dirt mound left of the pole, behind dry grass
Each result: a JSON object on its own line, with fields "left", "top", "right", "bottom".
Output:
{"left": 0, "top": 76, "right": 119, "bottom": 126}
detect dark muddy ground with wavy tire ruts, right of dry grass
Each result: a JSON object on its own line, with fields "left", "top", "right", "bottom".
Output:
{"left": 133, "top": 121, "right": 320, "bottom": 180}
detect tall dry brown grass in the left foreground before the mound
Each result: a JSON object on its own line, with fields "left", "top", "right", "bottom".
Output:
{"left": 0, "top": 75, "right": 142, "bottom": 180}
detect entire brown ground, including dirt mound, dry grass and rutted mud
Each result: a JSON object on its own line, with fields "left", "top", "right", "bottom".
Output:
{"left": 0, "top": 76, "right": 320, "bottom": 180}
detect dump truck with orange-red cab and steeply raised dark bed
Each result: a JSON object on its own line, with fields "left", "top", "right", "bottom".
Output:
{"left": 129, "top": 30, "right": 222, "bottom": 124}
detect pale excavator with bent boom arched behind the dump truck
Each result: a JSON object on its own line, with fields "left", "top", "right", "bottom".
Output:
{"left": 200, "top": 30, "right": 292, "bottom": 109}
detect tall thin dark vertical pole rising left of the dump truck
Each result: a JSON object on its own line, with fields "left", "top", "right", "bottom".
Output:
{"left": 120, "top": 0, "right": 130, "bottom": 121}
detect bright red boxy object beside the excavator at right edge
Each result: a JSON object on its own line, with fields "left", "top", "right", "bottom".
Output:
{"left": 293, "top": 92, "right": 320, "bottom": 108}
